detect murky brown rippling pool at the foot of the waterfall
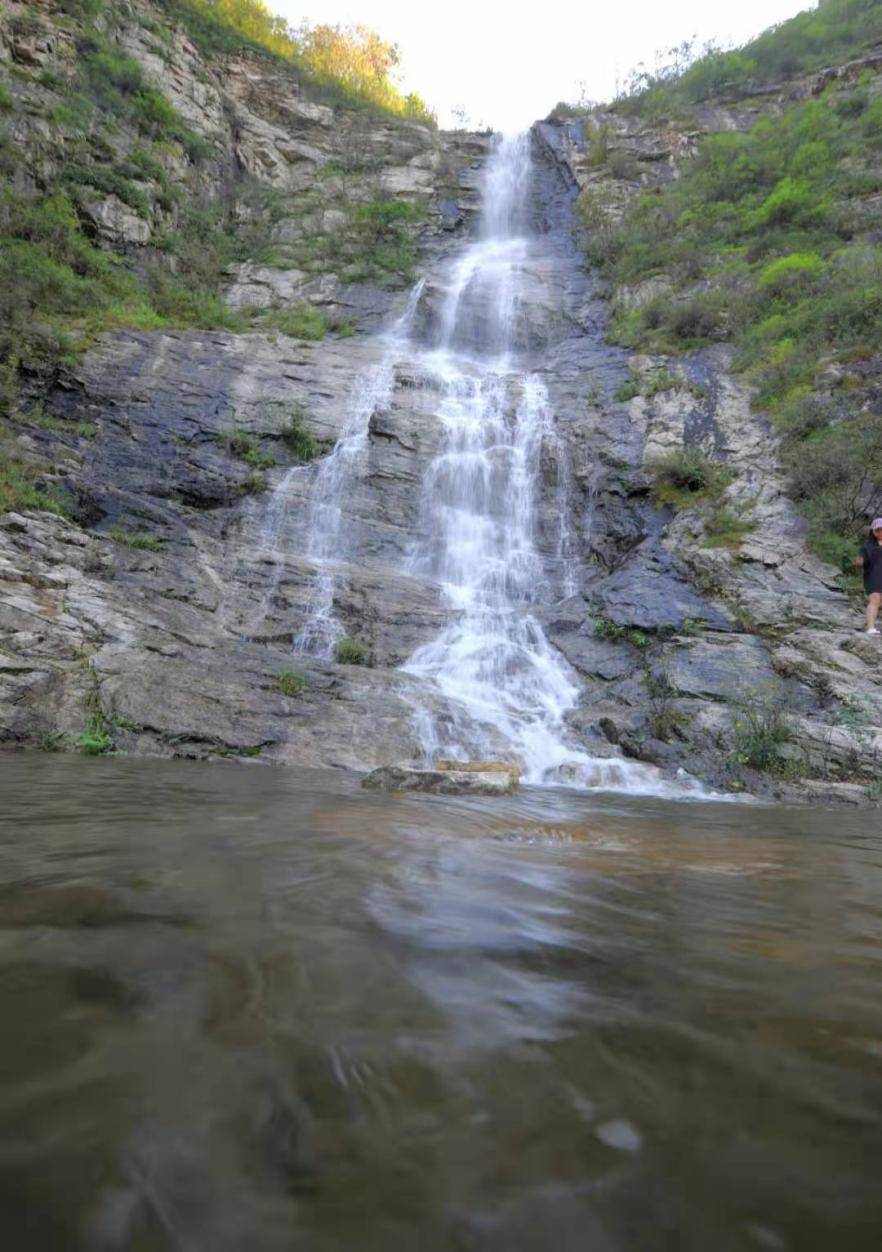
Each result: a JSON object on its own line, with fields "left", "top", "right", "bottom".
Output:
{"left": 0, "top": 756, "right": 882, "bottom": 1252}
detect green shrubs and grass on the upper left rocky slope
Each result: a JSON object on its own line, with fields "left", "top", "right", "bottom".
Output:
{"left": 0, "top": 6, "right": 272, "bottom": 412}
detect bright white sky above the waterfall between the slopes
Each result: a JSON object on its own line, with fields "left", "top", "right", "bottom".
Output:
{"left": 276, "top": 0, "right": 814, "bottom": 130}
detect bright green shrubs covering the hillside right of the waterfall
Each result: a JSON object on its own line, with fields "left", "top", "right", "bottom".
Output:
{"left": 581, "top": 0, "right": 882, "bottom": 573}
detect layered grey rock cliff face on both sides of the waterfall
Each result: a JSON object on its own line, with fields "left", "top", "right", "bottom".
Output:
{"left": 0, "top": 4, "right": 882, "bottom": 800}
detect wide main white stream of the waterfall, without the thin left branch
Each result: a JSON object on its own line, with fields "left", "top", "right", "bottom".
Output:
{"left": 405, "top": 135, "right": 696, "bottom": 791}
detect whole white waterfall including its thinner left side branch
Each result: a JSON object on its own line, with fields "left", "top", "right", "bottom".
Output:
{"left": 279, "top": 135, "right": 706, "bottom": 794}
